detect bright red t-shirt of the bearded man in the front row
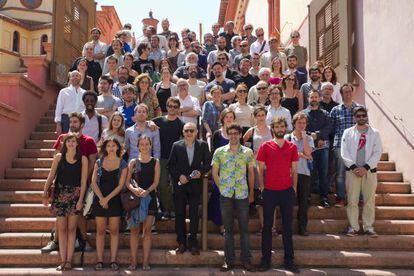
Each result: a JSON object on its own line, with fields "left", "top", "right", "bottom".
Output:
{"left": 256, "top": 140, "right": 299, "bottom": 191}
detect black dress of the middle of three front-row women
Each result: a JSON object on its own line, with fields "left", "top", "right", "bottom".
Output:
{"left": 92, "top": 167, "right": 122, "bottom": 217}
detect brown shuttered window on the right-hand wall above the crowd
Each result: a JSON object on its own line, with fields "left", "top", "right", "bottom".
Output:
{"left": 316, "top": 0, "right": 339, "bottom": 68}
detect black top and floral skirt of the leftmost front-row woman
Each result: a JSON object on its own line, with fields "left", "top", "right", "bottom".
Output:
{"left": 51, "top": 155, "right": 82, "bottom": 217}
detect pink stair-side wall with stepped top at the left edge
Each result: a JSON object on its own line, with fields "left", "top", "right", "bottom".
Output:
{"left": 0, "top": 56, "right": 58, "bottom": 178}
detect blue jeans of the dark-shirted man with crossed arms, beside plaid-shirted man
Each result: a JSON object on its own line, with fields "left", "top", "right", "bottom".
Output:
{"left": 312, "top": 148, "right": 329, "bottom": 200}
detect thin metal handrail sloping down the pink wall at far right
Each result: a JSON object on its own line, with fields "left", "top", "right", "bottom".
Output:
{"left": 353, "top": 68, "right": 414, "bottom": 149}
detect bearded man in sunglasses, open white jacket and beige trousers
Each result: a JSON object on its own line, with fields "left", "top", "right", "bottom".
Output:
{"left": 341, "top": 106, "right": 382, "bottom": 238}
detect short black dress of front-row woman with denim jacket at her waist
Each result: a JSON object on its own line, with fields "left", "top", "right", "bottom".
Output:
{"left": 128, "top": 157, "right": 158, "bottom": 228}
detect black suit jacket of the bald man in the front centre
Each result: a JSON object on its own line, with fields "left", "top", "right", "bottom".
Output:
{"left": 168, "top": 140, "right": 211, "bottom": 186}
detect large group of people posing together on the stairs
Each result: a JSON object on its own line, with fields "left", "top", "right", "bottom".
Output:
{"left": 42, "top": 19, "right": 382, "bottom": 272}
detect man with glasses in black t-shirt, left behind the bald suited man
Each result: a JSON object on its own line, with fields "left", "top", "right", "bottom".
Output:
{"left": 153, "top": 97, "right": 184, "bottom": 218}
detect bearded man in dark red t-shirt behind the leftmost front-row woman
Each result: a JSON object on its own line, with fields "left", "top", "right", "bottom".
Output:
{"left": 41, "top": 112, "right": 98, "bottom": 253}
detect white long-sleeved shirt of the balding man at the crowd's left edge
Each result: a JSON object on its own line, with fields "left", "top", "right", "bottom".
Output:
{"left": 55, "top": 85, "right": 85, "bottom": 123}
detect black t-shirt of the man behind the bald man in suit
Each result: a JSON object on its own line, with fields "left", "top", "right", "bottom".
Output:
{"left": 152, "top": 116, "right": 184, "bottom": 159}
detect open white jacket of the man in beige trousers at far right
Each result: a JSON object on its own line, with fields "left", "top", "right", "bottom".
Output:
{"left": 341, "top": 126, "right": 382, "bottom": 169}
